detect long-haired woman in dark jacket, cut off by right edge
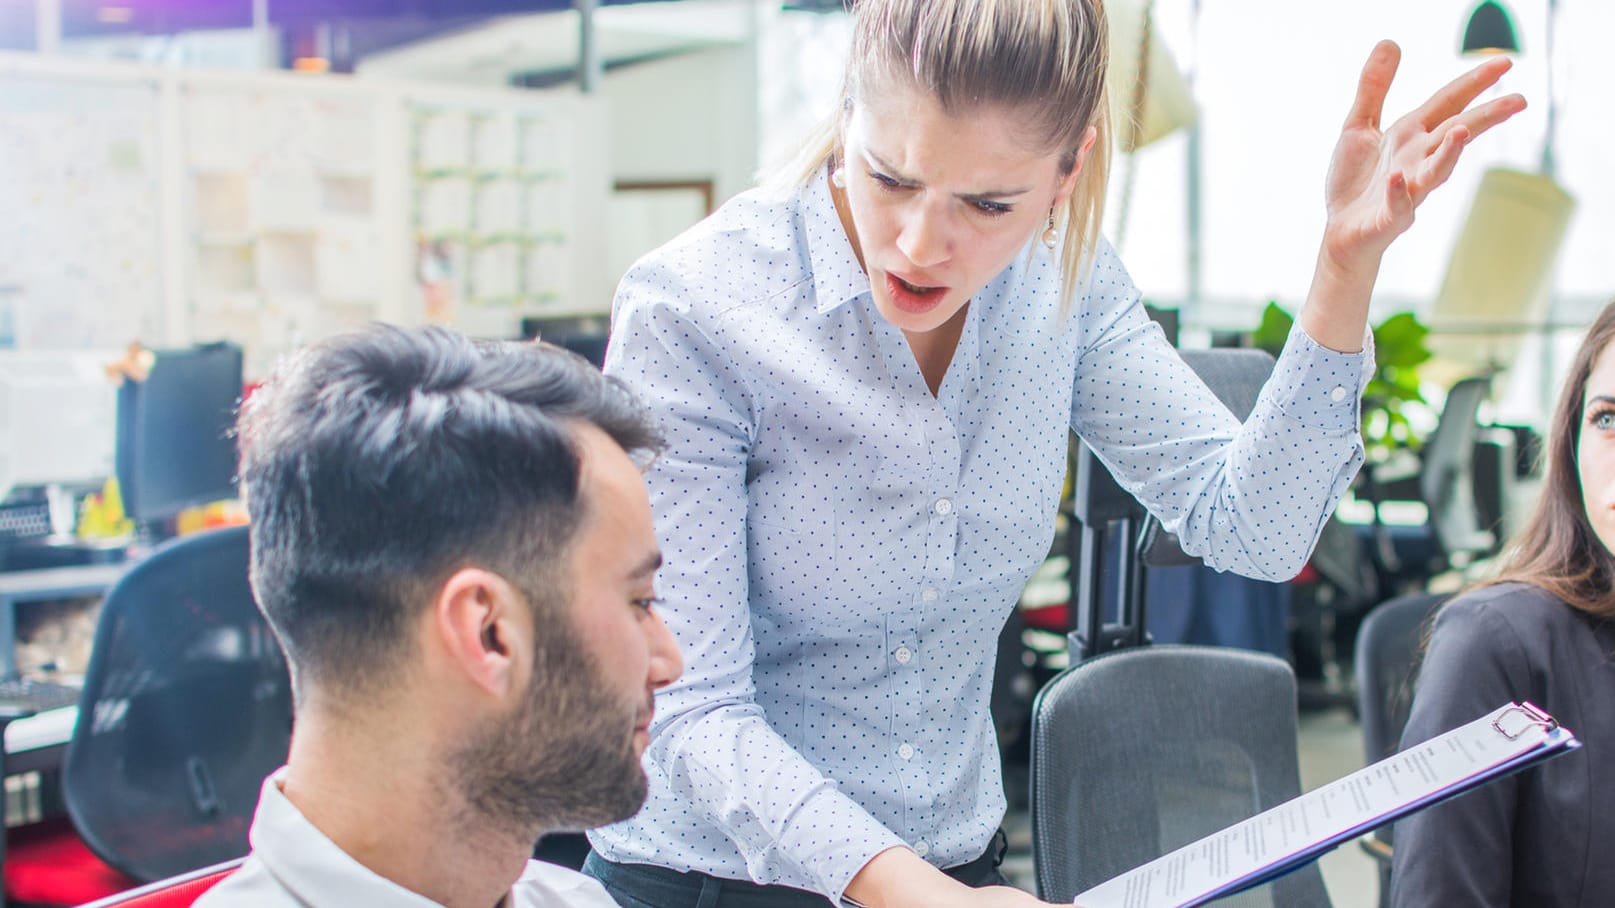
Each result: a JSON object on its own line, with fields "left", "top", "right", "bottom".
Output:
{"left": 1391, "top": 297, "right": 1615, "bottom": 908}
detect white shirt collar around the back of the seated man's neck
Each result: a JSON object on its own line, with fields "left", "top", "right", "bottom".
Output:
{"left": 247, "top": 766, "right": 455, "bottom": 908}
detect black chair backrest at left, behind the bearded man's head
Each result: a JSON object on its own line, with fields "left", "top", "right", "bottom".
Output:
{"left": 61, "top": 527, "right": 292, "bottom": 881}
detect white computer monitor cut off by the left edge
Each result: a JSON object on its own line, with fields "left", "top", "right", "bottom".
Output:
{"left": 0, "top": 351, "right": 120, "bottom": 501}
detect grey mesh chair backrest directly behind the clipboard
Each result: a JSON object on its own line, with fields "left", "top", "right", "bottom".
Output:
{"left": 1032, "top": 646, "right": 1329, "bottom": 908}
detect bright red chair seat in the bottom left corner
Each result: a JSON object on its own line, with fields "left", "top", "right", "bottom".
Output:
{"left": 5, "top": 818, "right": 139, "bottom": 905}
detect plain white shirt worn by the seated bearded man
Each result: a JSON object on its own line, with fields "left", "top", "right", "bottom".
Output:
{"left": 195, "top": 769, "right": 617, "bottom": 908}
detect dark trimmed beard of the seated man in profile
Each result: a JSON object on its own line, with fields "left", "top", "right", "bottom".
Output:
{"left": 451, "top": 609, "right": 649, "bottom": 835}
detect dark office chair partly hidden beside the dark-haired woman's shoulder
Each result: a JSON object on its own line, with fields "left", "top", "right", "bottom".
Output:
{"left": 1357, "top": 593, "right": 1447, "bottom": 908}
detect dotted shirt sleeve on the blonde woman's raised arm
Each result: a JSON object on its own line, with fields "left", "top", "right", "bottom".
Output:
{"left": 1071, "top": 247, "right": 1373, "bottom": 580}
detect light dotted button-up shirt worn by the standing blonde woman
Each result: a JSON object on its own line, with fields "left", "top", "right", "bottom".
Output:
{"left": 591, "top": 168, "right": 1373, "bottom": 900}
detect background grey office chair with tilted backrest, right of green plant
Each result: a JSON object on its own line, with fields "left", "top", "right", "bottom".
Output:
{"left": 1363, "top": 376, "right": 1497, "bottom": 585}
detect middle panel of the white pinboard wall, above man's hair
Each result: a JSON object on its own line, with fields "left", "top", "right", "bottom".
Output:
{"left": 178, "top": 79, "right": 394, "bottom": 375}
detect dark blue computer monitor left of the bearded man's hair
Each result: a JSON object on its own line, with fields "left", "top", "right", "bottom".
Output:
{"left": 116, "top": 344, "right": 241, "bottom": 528}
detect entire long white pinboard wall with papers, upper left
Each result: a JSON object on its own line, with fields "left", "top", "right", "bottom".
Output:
{"left": 0, "top": 52, "right": 610, "bottom": 371}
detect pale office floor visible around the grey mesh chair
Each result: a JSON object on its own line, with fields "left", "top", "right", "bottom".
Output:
{"left": 1003, "top": 709, "right": 1379, "bottom": 908}
